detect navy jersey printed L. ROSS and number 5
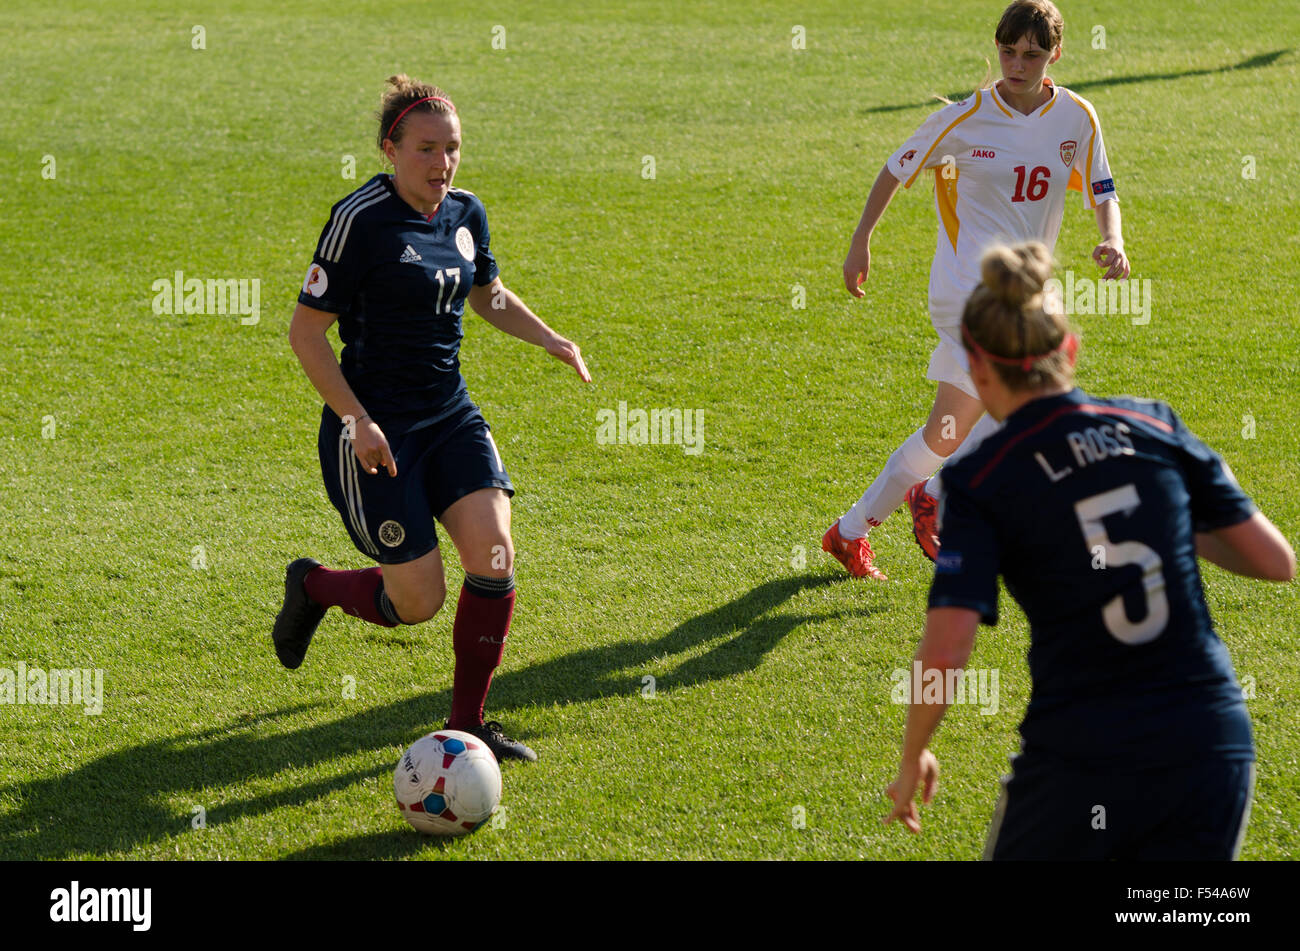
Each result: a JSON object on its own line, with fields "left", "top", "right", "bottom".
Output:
{"left": 930, "top": 390, "right": 1255, "bottom": 769}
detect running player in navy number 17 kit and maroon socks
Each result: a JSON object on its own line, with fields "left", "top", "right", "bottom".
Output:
{"left": 272, "top": 75, "right": 592, "bottom": 760}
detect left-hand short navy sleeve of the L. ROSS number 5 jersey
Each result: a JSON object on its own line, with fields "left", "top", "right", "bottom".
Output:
{"left": 928, "top": 478, "right": 998, "bottom": 626}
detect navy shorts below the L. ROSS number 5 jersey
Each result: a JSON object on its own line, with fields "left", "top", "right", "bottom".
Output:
{"left": 984, "top": 754, "right": 1255, "bottom": 861}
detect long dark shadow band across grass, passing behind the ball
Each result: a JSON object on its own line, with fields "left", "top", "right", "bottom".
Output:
{"left": 0, "top": 576, "right": 871, "bottom": 860}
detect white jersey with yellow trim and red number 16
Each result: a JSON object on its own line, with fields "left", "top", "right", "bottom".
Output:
{"left": 889, "top": 79, "right": 1117, "bottom": 327}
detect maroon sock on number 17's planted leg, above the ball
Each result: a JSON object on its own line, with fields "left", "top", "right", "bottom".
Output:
{"left": 447, "top": 574, "right": 515, "bottom": 730}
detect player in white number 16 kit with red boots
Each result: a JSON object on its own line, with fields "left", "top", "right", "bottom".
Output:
{"left": 822, "top": 0, "right": 1130, "bottom": 581}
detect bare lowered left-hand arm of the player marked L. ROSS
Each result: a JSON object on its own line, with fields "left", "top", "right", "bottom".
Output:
{"left": 884, "top": 608, "right": 979, "bottom": 833}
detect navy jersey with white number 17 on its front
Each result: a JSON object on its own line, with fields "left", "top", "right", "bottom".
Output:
{"left": 298, "top": 174, "right": 497, "bottom": 435}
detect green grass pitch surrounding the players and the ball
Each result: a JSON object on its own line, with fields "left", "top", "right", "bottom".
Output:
{"left": 0, "top": 0, "right": 1300, "bottom": 859}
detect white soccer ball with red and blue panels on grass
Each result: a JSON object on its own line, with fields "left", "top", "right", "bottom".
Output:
{"left": 393, "top": 730, "right": 501, "bottom": 835}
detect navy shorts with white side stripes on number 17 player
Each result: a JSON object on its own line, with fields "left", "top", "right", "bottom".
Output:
{"left": 317, "top": 404, "right": 515, "bottom": 565}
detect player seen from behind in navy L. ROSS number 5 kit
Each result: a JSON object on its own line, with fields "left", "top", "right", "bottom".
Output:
{"left": 887, "top": 243, "right": 1296, "bottom": 860}
